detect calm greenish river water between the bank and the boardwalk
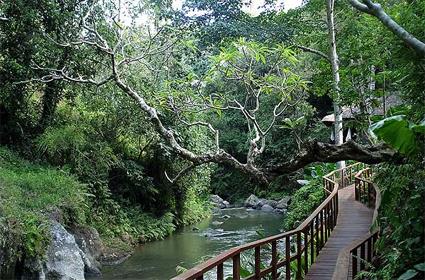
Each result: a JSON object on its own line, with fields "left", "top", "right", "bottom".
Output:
{"left": 101, "top": 208, "right": 283, "bottom": 280}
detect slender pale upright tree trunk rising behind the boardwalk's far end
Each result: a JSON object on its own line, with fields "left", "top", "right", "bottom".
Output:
{"left": 326, "top": 0, "right": 345, "bottom": 168}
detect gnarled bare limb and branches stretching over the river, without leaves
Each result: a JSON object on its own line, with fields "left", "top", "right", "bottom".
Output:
{"left": 27, "top": 3, "right": 400, "bottom": 184}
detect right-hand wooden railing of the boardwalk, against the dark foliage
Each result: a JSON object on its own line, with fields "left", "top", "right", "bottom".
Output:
{"left": 348, "top": 168, "right": 381, "bottom": 279}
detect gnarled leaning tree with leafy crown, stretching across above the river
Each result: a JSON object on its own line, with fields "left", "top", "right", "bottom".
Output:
{"left": 24, "top": 1, "right": 394, "bottom": 185}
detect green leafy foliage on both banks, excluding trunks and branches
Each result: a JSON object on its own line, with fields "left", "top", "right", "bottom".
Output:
{"left": 0, "top": 0, "right": 425, "bottom": 279}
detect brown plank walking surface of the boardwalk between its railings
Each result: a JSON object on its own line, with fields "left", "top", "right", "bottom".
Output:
{"left": 306, "top": 185, "right": 373, "bottom": 280}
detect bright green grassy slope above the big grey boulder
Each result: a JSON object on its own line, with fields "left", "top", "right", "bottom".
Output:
{"left": 0, "top": 148, "right": 87, "bottom": 265}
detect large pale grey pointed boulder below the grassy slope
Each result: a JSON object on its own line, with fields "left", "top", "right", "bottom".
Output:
{"left": 41, "top": 222, "right": 85, "bottom": 280}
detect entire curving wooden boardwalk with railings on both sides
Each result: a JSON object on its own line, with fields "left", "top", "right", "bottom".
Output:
{"left": 172, "top": 163, "right": 381, "bottom": 280}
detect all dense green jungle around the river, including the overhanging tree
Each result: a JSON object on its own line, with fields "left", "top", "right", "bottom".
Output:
{"left": 0, "top": 0, "right": 425, "bottom": 279}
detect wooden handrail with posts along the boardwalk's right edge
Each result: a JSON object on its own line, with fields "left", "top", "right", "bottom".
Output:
{"left": 333, "top": 168, "right": 381, "bottom": 279}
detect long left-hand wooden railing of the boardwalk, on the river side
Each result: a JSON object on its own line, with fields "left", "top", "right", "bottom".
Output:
{"left": 172, "top": 163, "right": 364, "bottom": 280}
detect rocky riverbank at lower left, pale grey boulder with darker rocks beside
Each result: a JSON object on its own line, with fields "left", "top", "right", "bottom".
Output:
{"left": 0, "top": 220, "right": 134, "bottom": 280}
